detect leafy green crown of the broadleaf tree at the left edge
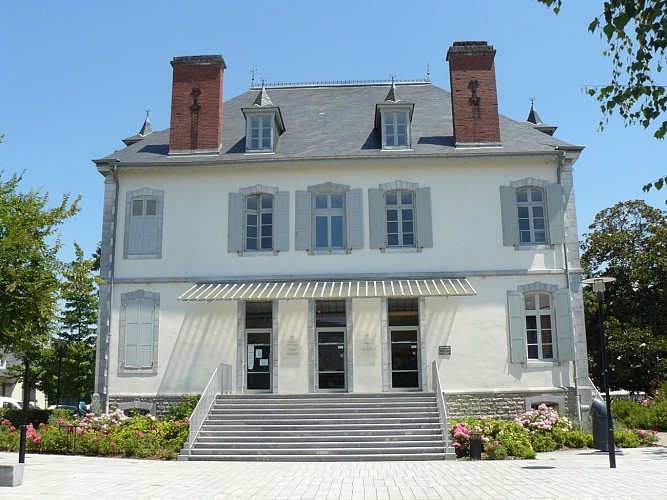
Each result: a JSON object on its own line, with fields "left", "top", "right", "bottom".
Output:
{"left": 0, "top": 171, "right": 79, "bottom": 359}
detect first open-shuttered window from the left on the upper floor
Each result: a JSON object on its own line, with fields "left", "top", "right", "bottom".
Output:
{"left": 228, "top": 185, "right": 289, "bottom": 255}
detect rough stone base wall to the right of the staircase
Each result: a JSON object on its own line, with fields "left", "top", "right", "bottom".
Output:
{"left": 445, "top": 389, "right": 577, "bottom": 420}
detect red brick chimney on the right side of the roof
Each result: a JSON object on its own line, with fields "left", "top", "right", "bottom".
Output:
{"left": 447, "top": 42, "right": 500, "bottom": 146}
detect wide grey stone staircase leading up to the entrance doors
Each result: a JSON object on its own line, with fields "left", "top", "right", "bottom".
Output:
{"left": 179, "top": 393, "right": 454, "bottom": 461}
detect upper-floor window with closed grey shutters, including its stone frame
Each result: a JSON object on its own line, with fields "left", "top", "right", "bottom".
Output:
{"left": 123, "top": 187, "right": 164, "bottom": 259}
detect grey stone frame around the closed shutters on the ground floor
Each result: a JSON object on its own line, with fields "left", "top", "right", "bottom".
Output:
{"left": 118, "top": 290, "right": 160, "bottom": 374}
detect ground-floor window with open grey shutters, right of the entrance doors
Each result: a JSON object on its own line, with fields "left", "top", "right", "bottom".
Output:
{"left": 507, "top": 283, "right": 574, "bottom": 363}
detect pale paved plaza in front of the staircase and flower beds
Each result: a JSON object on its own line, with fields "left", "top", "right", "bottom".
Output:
{"left": 0, "top": 446, "right": 667, "bottom": 500}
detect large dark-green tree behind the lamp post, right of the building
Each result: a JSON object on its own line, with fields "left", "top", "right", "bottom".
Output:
{"left": 581, "top": 200, "right": 667, "bottom": 390}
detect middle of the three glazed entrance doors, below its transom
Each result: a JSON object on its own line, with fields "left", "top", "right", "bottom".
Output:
{"left": 317, "top": 330, "right": 346, "bottom": 391}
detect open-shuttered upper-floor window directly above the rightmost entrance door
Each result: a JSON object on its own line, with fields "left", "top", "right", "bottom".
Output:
{"left": 368, "top": 181, "right": 433, "bottom": 251}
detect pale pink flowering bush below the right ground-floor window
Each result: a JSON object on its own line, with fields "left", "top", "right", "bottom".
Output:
{"left": 514, "top": 404, "right": 573, "bottom": 451}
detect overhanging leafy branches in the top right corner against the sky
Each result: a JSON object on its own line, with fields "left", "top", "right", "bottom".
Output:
{"left": 538, "top": 0, "right": 667, "bottom": 191}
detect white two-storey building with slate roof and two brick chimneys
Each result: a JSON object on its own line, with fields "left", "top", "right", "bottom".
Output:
{"left": 95, "top": 42, "right": 591, "bottom": 416}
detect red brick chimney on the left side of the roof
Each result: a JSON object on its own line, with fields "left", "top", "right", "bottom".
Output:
{"left": 169, "top": 55, "right": 226, "bottom": 154}
